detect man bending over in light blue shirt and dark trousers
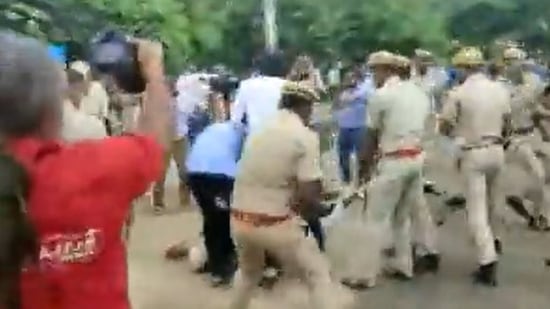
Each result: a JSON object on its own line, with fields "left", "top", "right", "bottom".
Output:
{"left": 185, "top": 121, "right": 245, "bottom": 286}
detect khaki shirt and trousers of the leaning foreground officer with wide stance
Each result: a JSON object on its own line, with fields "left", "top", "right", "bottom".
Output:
{"left": 230, "top": 110, "right": 341, "bottom": 309}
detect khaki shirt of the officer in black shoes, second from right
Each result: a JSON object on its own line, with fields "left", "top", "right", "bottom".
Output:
{"left": 441, "top": 73, "right": 511, "bottom": 144}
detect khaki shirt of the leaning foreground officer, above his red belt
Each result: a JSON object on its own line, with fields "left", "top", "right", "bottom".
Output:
{"left": 232, "top": 110, "right": 322, "bottom": 216}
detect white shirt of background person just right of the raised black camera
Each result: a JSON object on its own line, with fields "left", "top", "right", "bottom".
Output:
{"left": 175, "top": 73, "right": 210, "bottom": 137}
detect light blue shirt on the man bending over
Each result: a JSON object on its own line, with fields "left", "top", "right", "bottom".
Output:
{"left": 185, "top": 121, "right": 245, "bottom": 178}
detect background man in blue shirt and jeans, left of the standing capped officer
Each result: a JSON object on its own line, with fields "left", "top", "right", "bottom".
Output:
{"left": 335, "top": 69, "right": 375, "bottom": 185}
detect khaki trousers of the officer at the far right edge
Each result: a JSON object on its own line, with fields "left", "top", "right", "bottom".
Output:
{"left": 507, "top": 136, "right": 548, "bottom": 217}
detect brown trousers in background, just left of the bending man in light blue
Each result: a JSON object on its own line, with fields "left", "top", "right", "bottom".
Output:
{"left": 153, "top": 137, "right": 190, "bottom": 207}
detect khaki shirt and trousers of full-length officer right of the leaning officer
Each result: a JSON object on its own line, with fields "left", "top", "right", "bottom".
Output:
{"left": 363, "top": 76, "right": 435, "bottom": 286}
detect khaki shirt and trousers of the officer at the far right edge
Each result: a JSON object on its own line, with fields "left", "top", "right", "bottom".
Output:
{"left": 507, "top": 82, "right": 545, "bottom": 217}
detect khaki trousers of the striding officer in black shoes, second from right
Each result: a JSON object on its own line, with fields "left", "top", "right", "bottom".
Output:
{"left": 460, "top": 145, "right": 504, "bottom": 265}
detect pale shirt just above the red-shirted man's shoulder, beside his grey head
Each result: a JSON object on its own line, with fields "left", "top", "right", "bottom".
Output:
{"left": 61, "top": 101, "right": 107, "bottom": 142}
